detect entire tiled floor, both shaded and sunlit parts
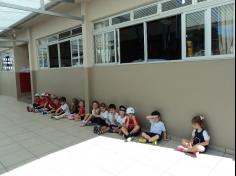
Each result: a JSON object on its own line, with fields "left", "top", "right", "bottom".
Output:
{"left": 0, "top": 96, "right": 235, "bottom": 176}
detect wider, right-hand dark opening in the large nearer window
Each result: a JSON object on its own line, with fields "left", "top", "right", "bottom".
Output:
{"left": 147, "top": 15, "right": 181, "bottom": 61}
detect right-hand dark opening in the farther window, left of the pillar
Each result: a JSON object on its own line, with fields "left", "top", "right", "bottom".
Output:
{"left": 60, "top": 41, "right": 71, "bottom": 67}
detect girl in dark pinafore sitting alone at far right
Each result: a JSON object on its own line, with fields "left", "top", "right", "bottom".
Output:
{"left": 177, "top": 115, "right": 210, "bottom": 156}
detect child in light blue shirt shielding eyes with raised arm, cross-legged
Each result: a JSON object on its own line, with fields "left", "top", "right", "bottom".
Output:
{"left": 139, "top": 111, "right": 168, "bottom": 144}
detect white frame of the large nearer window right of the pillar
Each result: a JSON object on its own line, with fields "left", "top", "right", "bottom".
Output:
{"left": 93, "top": 0, "right": 235, "bottom": 65}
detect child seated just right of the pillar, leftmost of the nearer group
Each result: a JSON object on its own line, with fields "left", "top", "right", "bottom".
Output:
{"left": 80, "top": 101, "right": 100, "bottom": 127}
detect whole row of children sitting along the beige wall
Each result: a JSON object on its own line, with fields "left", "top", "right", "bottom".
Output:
{"left": 27, "top": 93, "right": 210, "bottom": 155}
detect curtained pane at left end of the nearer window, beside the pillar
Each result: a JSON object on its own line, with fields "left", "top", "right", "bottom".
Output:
{"left": 95, "top": 31, "right": 116, "bottom": 64}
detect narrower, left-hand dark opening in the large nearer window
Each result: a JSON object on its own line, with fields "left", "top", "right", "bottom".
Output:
{"left": 120, "top": 24, "right": 144, "bottom": 63}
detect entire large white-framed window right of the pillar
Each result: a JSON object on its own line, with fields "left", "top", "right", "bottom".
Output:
{"left": 94, "top": 0, "right": 235, "bottom": 64}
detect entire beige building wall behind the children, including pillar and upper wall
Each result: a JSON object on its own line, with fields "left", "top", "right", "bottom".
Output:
{"left": 3, "top": 0, "right": 235, "bottom": 149}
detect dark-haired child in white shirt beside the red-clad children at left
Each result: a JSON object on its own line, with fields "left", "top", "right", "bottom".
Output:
{"left": 51, "top": 97, "right": 70, "bottom": 120}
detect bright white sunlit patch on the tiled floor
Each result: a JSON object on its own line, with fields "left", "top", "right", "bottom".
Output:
{"left": 2, "top": 136, "right": 235, "bottom": 176}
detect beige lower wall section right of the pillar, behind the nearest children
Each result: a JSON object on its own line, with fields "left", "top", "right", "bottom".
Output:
{"left": 91, "top": 60, "right": 235, "bottom": 149}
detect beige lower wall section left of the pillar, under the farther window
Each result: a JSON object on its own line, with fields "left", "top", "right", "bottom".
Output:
{"left": 34, "top": 68, "right": 84, "bottom": 101}
